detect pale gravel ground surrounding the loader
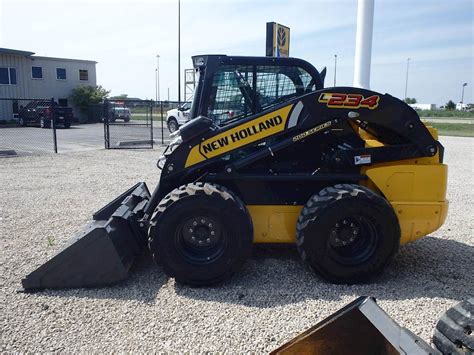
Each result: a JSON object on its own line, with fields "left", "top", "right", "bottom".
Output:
{"left": 0, "top": 137, "right": 474, "bottom": 353}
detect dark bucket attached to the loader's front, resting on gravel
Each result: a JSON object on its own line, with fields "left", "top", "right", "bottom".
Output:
{"left": 22, "top": 182, "right": 150, "bottom": 291}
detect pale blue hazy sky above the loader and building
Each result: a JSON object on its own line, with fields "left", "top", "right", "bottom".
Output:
{"left": 0, "top": 0, "right": 474, "bottom": 106}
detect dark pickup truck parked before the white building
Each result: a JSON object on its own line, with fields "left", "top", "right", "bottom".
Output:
{"left": 18, "top": 100, "right": 74, "bottom": 128}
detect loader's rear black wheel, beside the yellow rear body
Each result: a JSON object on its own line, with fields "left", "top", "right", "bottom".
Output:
{"left": 296, "top": 184, "right": 400, "bottom": 284}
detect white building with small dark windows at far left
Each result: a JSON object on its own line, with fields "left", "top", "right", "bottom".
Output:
{"left": 0, "top": 48, "right": 97, "bottom": 120}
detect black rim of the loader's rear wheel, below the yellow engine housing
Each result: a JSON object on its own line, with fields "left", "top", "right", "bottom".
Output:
{"left": 328, "top": 216, "right": 379, "bottom": 266}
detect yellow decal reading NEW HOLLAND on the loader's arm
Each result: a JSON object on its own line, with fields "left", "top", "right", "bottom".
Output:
{"left": 185, "top": 105, "right": 293, "bottom": 168}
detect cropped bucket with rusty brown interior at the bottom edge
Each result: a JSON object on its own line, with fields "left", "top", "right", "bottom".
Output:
{"left": 271, "top": 297, "right": 440, "bottom": 355}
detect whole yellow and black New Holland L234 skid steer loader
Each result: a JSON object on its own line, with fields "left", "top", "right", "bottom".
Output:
{"left": 23, "top": 55, "right": 448, "bottom": 290}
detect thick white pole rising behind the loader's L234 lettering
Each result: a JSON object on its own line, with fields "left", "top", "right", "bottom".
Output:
{"left": 354, "top": 0, "right": 375, "bottom": 89}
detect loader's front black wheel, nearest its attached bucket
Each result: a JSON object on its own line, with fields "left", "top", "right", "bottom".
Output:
{"left": 148, "top": 182, "right": 253, "bottom": 286}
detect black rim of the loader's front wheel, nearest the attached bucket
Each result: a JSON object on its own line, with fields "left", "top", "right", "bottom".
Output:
{"left": 175, "top": 215, "right": 227, "bottom": 264}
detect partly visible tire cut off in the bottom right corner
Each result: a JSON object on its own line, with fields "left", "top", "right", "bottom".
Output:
{"left": 433, "top": 298, "right": 474, "bottom": 354}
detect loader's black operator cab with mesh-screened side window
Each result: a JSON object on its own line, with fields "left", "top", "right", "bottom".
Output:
{"left": 191, "top": 55, "right": 324, "bottom": 126}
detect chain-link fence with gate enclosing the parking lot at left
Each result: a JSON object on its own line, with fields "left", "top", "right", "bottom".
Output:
{"left": 0, "top": 98, "right": 190, "bottom": 156}
